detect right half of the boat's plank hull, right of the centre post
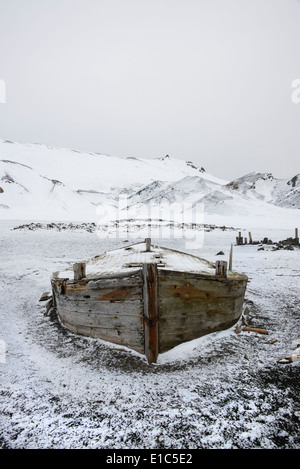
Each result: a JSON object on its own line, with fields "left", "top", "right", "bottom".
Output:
{"left": 158, "top": 270, "right": 247, "bottom": 353}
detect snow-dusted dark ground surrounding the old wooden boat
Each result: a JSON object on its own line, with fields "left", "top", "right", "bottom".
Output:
{"left": 0, "top": 221, "right": 300, "bottom": 449}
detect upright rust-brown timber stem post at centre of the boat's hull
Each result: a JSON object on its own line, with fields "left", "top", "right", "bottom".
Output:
{"left": 143, "top": 264, "right": 159, "bottom": 363}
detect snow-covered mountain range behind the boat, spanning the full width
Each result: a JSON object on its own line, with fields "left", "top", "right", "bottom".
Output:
{"left": 0, "top": 140, "right": 300, "bottom": 226}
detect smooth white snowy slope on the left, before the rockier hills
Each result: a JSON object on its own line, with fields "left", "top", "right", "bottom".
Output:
{"left": 0, "top": 140, "right": 225, "bottom": 221}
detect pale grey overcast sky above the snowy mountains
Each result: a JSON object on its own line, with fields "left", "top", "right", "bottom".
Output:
{"left": 0, "top": 0, "right": 300, "bottom": 179}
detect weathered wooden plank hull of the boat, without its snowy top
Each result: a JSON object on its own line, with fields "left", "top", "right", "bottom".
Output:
{"left": 51, "top": 264, "right": 247, "bottom": 363}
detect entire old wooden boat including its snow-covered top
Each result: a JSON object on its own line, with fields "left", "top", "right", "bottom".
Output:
{"left": 51, "top": 239, "right": 247, "bottom": 363}
